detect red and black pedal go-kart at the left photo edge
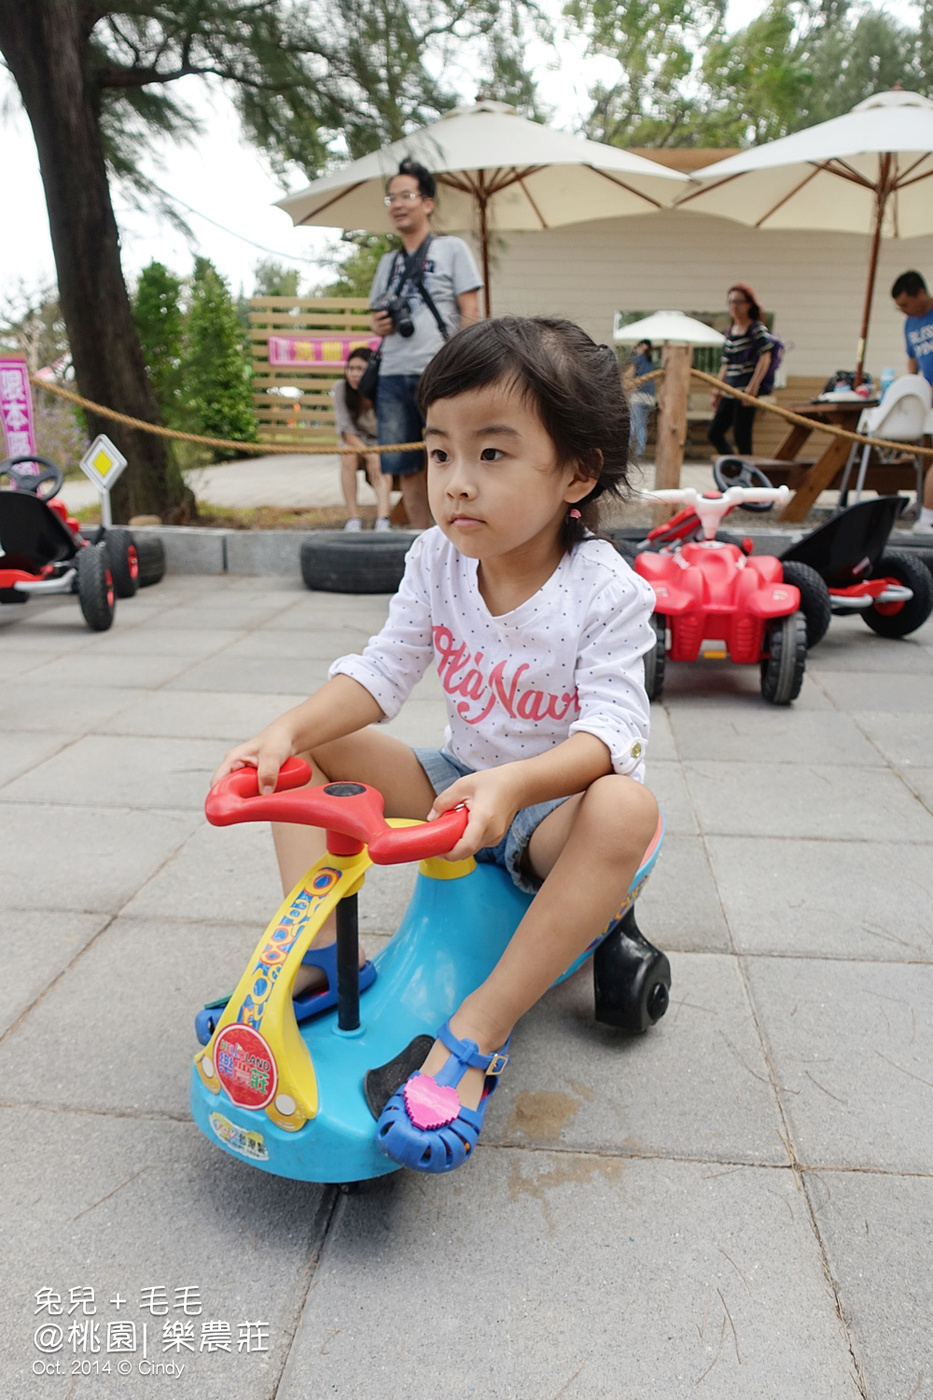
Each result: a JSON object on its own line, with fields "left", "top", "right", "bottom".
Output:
{"left": 0, "top": 456, "right": 139, "bottom": 631}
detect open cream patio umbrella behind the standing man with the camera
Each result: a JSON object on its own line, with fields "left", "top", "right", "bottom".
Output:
{"left": 276, "top": 102, "right": 686, "bottom": 315}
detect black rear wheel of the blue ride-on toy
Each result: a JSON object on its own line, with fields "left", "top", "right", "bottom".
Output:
{"left": 593, "top": 909, "right": 671, "bottom": 1035}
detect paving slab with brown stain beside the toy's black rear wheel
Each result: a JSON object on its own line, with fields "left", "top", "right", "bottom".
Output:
{"left": 483, "top": 953, "right": 787, "bottom": 1166}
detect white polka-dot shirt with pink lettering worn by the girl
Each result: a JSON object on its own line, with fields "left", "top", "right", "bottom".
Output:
{"left": 329, "top": 528, "right": 654, "bottom": 781}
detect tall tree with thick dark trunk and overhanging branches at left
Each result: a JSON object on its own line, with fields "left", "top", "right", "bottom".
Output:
{"left": 0, "top": 0, "right": 537, "bottom": 519}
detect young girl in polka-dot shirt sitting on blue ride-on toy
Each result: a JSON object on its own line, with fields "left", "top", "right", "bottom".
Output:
{"left": 214, "top": 316, "right": 658, "bottom": 1172}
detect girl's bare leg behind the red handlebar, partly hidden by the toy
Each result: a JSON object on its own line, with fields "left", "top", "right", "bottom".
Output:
{"left": 272, "top": 728, "right": 434, "bottom": 993}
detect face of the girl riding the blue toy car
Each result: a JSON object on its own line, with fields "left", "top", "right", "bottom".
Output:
{"left": 424, "top": 382, "right": 593, "bottom": 570}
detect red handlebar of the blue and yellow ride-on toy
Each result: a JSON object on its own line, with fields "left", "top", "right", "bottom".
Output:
{"left": 205, "top": 759, "right": 469, "bottom": 865}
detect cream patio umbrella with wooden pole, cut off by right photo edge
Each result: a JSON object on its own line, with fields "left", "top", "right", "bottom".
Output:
{"left": 675, "top": 88, "right": 933, "bottom": 379}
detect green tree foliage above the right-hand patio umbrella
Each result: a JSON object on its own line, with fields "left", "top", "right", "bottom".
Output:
{"left": 566, "top": 0, "right": 933, "bottom": 146}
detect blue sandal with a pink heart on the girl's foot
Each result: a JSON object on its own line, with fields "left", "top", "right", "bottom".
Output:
{"left": 375, "top": 1021, "right": 511, "bottom": 1172}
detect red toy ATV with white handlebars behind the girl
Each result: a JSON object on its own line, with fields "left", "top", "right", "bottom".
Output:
{"left": 632, "top": 486, "right": 807, "bottom": 704}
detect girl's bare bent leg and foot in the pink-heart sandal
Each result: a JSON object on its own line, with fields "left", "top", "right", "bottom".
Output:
{"left": 423, "top": 774, "right": 658, "bottom": 1109}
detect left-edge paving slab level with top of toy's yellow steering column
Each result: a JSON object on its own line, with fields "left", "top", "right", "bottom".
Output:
{"left": 0, "top": 802, "right": 200, "bottom": 914}
